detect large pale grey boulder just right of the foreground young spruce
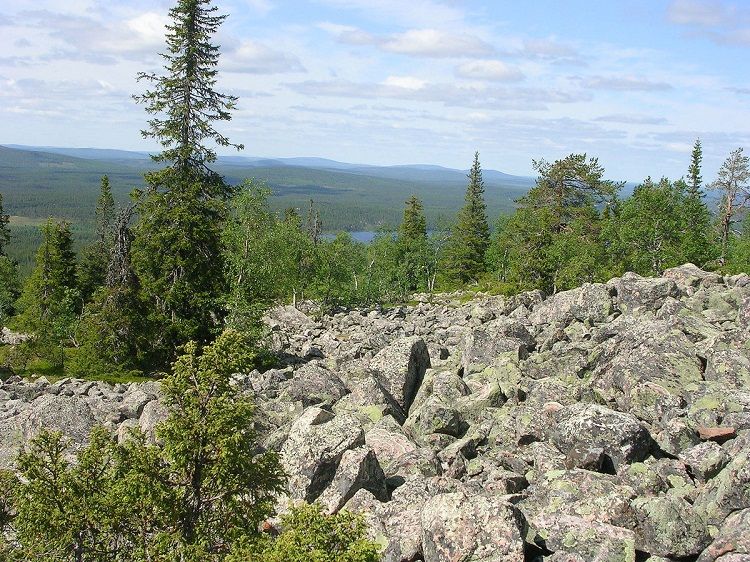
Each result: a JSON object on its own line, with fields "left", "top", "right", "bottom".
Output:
{"left": 281, "top": 406, "right": 365, "bottom": 502}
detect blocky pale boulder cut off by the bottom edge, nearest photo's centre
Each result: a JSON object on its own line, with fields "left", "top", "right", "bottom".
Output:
{"left": 422, "top": 491, "right": 526, "bottom": 562}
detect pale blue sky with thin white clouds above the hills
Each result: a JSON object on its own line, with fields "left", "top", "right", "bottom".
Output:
{"left": 0, "top": 0, "right": 750, "bottom": 182}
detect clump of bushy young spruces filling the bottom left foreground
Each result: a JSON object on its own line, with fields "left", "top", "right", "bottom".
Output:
{"left": 0, "top": 330, "right": 284, "bottom": 562}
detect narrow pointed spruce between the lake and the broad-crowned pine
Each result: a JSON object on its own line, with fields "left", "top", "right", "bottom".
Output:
{"left": 446, "top": 152, "right": 490, "bottom": 283}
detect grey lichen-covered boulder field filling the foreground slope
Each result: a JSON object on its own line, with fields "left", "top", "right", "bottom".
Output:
{"left": 0, "top": 265, "right": 750, "bottom": 562}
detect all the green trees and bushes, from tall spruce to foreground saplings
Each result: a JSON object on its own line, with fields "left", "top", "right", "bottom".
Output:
{"left": 0, "top": 0, "right": 750, "bottom": 562}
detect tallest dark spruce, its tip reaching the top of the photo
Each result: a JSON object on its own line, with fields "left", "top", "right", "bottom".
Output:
{"left": 132, "top": 0, "right": 242, "bottom": 364}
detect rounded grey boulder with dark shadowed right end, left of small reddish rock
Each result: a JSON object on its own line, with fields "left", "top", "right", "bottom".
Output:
{"left": 552, "top": 404, "right": 653, "bottom": 471}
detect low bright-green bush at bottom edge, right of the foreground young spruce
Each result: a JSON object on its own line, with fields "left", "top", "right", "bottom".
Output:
{"left": 227, "top": 504, "right": 380, "bottom": 562}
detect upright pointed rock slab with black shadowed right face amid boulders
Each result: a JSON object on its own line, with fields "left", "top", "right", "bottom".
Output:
{"left": 370, "top": 337, "right": 430, "bottom": 412}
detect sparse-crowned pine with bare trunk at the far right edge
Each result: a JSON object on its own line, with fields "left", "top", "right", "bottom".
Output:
{"left": 709, "top": 148, "right": 750, "bottom": 265}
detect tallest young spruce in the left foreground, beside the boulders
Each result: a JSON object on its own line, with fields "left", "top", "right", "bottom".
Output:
{"left": 150, "top": 330, "right": 283, "bottom": 551}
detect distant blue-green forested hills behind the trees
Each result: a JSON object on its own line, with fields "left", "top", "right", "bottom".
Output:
{"left": 0, "top": 145, "right": 533, "bottom": 272}
